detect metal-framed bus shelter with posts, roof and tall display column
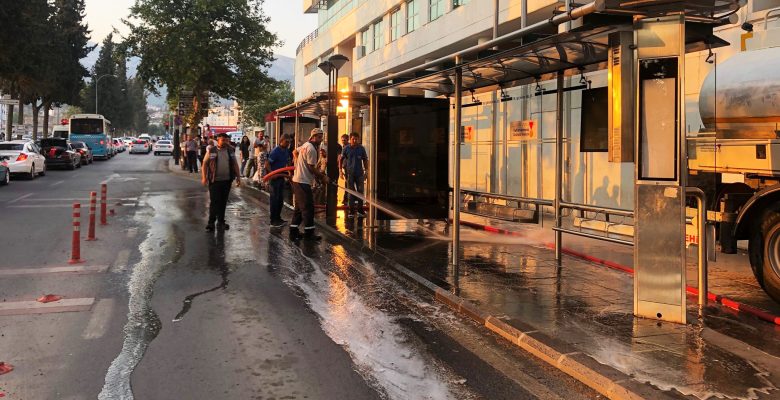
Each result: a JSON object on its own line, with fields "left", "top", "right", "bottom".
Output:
{"left": 368, "top": 1, "right": 740, "bottom": 323}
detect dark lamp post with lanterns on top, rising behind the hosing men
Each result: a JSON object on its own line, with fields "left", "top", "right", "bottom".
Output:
{"left": 318, "top": 54, "right": 349, "bottom": 225}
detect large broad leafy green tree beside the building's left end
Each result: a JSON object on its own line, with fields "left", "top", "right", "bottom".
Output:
{"left": 125, "top": 0, "right": 279, "bottom": 125}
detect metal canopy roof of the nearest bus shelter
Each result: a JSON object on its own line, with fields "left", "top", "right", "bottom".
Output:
{"left": 374, "top": 1, "right": 738, "bottom": 96}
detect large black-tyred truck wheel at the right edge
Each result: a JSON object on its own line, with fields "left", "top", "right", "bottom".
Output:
{"left": 749, "top": 211, "right": 780, "bottom": 303}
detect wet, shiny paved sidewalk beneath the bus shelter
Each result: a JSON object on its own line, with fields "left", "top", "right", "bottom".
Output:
{"left": 326, "top": 214, "right": 780, "bottom": 398}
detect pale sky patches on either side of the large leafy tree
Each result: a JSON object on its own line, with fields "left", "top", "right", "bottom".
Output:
{"left": 86, "top": 0, "right": 317, "bottom": 58}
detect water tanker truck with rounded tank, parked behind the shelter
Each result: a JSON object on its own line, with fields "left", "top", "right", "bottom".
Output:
{"left": 688, "top": 43, "right": 780, "bottom": 302}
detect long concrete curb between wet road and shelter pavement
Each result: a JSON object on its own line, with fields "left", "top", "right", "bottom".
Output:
{"left": 308, "top": 221, "right": 673, "bottom": 400}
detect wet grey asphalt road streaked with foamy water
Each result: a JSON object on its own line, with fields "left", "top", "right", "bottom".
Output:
{"left": 0, "top": 154, "right": 597, "bottom": 399}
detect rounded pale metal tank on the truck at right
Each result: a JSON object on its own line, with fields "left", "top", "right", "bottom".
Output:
{"left": 699, "top": 47, "right": 780, "bottom": 139}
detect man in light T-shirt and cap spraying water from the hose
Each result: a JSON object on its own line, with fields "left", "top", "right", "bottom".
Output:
{"left": 290, "top": 128, "right": 328, "bottom": 241}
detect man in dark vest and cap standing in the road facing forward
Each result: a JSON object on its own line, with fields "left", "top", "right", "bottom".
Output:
{"left": 201, "top": 133, "right": 241, "bottom": 231}
